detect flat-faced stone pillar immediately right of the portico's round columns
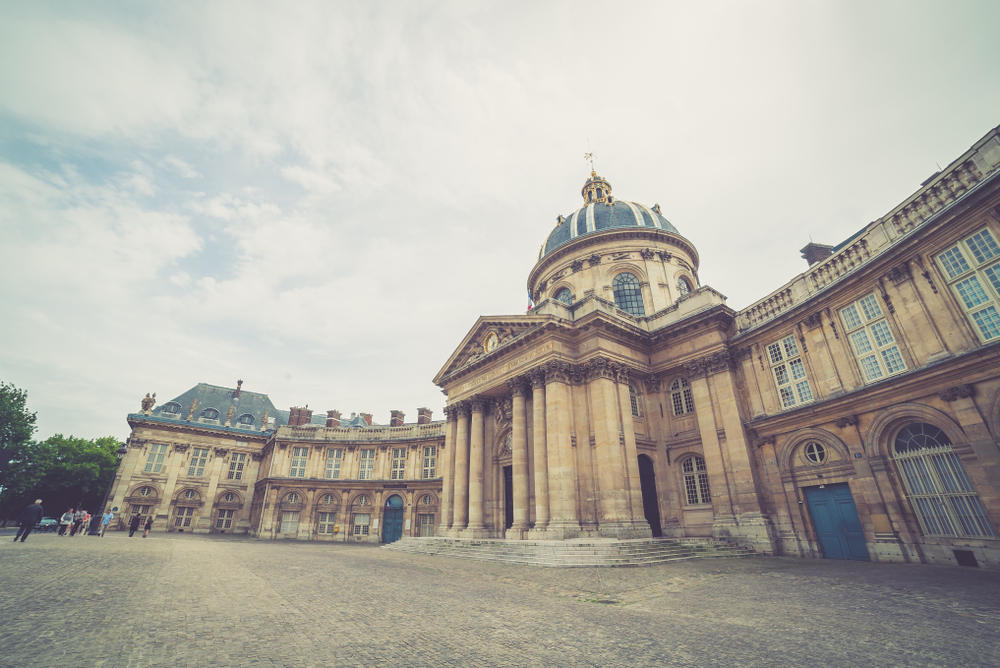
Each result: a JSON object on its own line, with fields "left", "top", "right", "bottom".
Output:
{"left": 545, "top": 361, "right": 580, "bottom": 539}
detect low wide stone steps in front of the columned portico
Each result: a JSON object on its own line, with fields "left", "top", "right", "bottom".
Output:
{"left": 382, "top": 537, "right": 757, "bottom": 568}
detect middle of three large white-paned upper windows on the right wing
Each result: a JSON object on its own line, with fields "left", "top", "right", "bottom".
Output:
{"left": 840, "top": 292, "right": 906, "bottom": 383}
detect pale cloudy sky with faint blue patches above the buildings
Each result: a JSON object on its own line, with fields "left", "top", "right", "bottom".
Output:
{"left": 0, "top": 0, "right": 1000, "bottom": 439}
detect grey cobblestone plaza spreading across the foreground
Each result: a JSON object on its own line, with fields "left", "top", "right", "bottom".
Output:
{"left": 0, "top": 529, "right": 1000, "bottom": 668}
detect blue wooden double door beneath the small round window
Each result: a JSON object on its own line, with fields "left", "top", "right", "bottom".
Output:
{"left": 805, "top": 483, "right": 871, "bottom": 561}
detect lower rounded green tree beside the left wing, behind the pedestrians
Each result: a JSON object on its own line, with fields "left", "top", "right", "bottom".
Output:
{"left": 0, "top": 434, "right": 121, "bottom": 518}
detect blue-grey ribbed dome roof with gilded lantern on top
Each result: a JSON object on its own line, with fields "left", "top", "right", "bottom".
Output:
{"left": 538, "top": 172, "right": 679, "bottom": 260}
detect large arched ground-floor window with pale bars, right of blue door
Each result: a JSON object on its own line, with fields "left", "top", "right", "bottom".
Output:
{"left": 892, "top": 422, "right": 996, "bottom": 538}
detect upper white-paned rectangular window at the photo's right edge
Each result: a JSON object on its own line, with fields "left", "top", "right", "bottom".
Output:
{"left": 937, "top": 228, "right": 1000, "bottom": 343}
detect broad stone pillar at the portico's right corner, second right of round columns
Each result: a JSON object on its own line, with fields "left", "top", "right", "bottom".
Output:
{"left": 587, "top": 357, "right": 630, "bottom": 538}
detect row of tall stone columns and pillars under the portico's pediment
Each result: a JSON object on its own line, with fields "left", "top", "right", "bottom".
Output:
{"left": 438, "top": 357, "right": 650, "bottom": 539}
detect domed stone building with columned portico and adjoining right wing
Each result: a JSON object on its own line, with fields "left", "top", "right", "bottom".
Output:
{"left": 434, "top": 129, "right": 1000, "bottom": 566}
